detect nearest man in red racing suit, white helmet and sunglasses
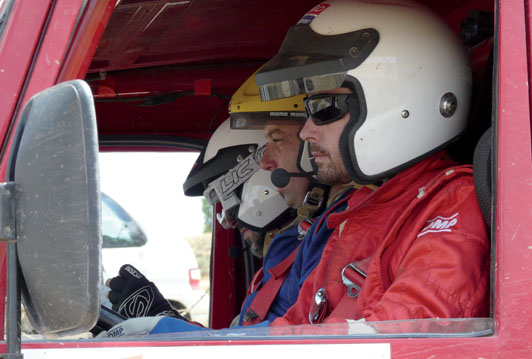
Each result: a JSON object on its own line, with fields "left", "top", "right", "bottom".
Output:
{"left": 255, "top": 0, "right": 489, "bottom": 326}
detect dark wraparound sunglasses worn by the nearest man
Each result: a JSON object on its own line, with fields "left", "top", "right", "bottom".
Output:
{"left": 305, "top": 93, "right": 358, "bottom": 126}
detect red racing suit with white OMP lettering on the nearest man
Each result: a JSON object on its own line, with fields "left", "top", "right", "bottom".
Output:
{"left": 271, "top": 153, "right": 490, "bottom": 326}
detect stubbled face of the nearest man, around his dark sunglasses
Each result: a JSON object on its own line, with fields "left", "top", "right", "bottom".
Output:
{"left": 299, "top": 88, "right": 351, "bottom": 186}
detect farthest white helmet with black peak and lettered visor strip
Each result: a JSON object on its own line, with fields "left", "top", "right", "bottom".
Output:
{"left": 183, "top": 119, "right": 290, "bottom": 232}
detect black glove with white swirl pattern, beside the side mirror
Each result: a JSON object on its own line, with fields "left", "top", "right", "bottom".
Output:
{"left": 107, "top": 264, "right": 187, "bottom": 321}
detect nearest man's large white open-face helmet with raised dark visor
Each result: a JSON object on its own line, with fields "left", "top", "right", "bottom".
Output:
{"left": 255, "top": 0, "right": 471, "bottom": 184}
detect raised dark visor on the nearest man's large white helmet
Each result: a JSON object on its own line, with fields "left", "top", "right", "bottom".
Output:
{"left": 255, "top": 24, "right": 379, "bottom": 101}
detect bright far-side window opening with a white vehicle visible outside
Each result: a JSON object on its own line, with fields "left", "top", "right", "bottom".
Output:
{"left": 100, "top": 152, "right": 211, "bottom": 326}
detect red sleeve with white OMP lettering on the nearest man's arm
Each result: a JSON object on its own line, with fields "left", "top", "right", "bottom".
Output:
{"left": 362, "top": 178, "right": 490, "bottom": 321}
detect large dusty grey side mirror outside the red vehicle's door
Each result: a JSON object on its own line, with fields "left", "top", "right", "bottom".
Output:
{"left": 0, "top": 80, "right": 102, "bottom": 335}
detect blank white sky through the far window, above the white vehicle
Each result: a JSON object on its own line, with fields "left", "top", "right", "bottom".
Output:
{"left": 99, "top": 152, "right": 203, "bottom": 239}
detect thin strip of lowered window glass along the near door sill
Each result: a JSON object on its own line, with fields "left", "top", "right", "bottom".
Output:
{"left": 131, "top": 318, "right": 493, "bottom": 341}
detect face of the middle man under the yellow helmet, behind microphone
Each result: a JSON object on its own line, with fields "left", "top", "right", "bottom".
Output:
{"left": 260, "top": 124, "right": 309, "bottom": 208}
